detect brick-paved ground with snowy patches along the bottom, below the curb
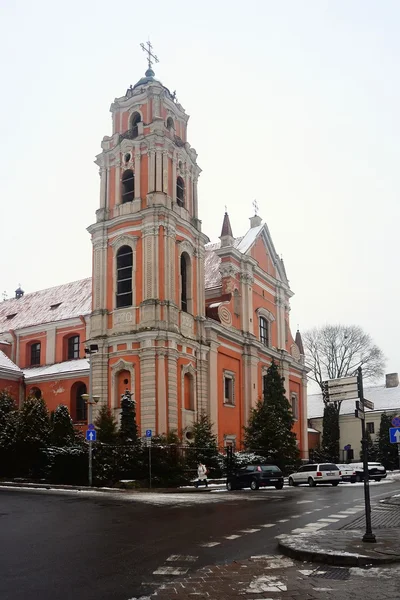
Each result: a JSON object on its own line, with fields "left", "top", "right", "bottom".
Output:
{"left": 143, "top": 556, "right": 400, "bottom": 600}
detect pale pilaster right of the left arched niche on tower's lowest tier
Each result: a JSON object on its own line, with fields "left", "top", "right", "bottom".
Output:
{"left": 139, "top": 347, "right": 156, "bottom": 435}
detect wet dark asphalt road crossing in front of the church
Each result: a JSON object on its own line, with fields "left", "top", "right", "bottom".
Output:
{"left": 0, "top": 481, "right": 400, "bottom": 600}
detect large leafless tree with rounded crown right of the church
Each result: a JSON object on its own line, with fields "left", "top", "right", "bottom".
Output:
{"left": 303, "top": 325, "right": 386, "bottom": 398}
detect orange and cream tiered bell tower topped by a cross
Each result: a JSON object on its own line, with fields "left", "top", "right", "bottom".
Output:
{"left": 88, "top": 42, "right": 208, "bottom": 433}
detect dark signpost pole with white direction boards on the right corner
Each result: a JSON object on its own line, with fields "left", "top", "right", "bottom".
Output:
{"left": 322, "top": 367, "right": 376, "bottom": 543}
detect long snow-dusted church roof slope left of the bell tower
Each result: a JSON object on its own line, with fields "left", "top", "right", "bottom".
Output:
{"left": 0, "top": 277, "right": 92, "bottom": 332}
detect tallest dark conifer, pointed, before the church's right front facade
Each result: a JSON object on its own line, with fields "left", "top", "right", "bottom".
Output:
{"left": 245, "top": 361, "right": 299, "bottom": 468}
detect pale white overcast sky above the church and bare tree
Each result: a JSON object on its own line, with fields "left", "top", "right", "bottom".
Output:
{"left": 0, "top": 0, "right": 400, "bottom": 380}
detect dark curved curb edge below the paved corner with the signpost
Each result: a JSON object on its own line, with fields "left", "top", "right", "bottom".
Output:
{"left": 278, "top": 540, "right": 400, "bottom": 567}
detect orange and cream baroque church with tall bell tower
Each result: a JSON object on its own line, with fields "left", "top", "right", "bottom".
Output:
{"left": 0, "top": 43, "right": 308, "bottom": 456}
